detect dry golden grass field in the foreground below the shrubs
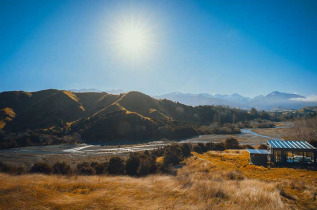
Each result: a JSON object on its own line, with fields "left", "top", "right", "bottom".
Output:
{"left": 0, "top": 150, "right": 317, "bottom": 209}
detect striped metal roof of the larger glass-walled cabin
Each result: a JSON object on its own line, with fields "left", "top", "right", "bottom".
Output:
{"left": 267, "top": 140, "right": 316, "bottom": 149}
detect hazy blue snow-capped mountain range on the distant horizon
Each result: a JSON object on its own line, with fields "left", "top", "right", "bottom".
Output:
{"left": 155, "top": 91, "right": 317, "bottom": 111}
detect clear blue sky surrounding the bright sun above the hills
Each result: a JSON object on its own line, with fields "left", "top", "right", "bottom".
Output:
{"left": 0, "top": 0, "right": 317, "bottom": 97}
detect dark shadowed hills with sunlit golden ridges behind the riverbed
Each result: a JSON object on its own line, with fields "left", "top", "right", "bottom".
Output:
{"left": 0, "top": 89, "right": 249, "bottom": 146}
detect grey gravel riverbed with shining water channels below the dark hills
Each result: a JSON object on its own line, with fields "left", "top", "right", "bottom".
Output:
{"left": 0, "top": 124, "right": 291, "bottom": 167}
